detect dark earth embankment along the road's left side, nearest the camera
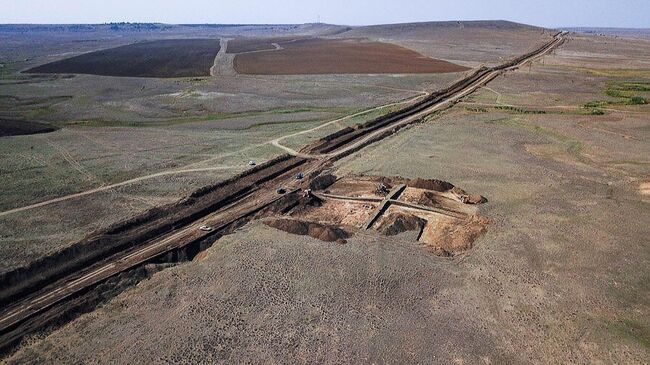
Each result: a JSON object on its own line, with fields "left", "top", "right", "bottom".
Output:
{"left": 0, "top": 155, "right": 305, "bottom": 304}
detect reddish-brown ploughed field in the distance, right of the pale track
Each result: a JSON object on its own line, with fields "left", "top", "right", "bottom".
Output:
{"left": 234, "top": 39, "right": 467, "bottom": 75}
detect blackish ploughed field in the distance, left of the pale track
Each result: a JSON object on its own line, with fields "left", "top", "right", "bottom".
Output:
{"left": 27, "top": 39, "right": 220, "bottom": 78}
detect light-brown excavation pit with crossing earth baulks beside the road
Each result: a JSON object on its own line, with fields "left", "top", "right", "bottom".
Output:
{"left": 266, "top": 175, "right": 489, "bottom": 256}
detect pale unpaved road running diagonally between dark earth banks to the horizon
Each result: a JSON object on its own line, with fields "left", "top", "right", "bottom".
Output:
{"left": 0, "top": 35, "right": 563, "bottom": 348}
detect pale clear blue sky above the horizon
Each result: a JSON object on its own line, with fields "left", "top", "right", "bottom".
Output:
{"left": 0, "top": 0, "right": 650, "bottom": 28}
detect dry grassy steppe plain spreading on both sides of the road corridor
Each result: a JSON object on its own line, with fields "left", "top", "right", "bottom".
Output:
{"left": 0, "top": 21, "right": 650, "bottom": 364}
